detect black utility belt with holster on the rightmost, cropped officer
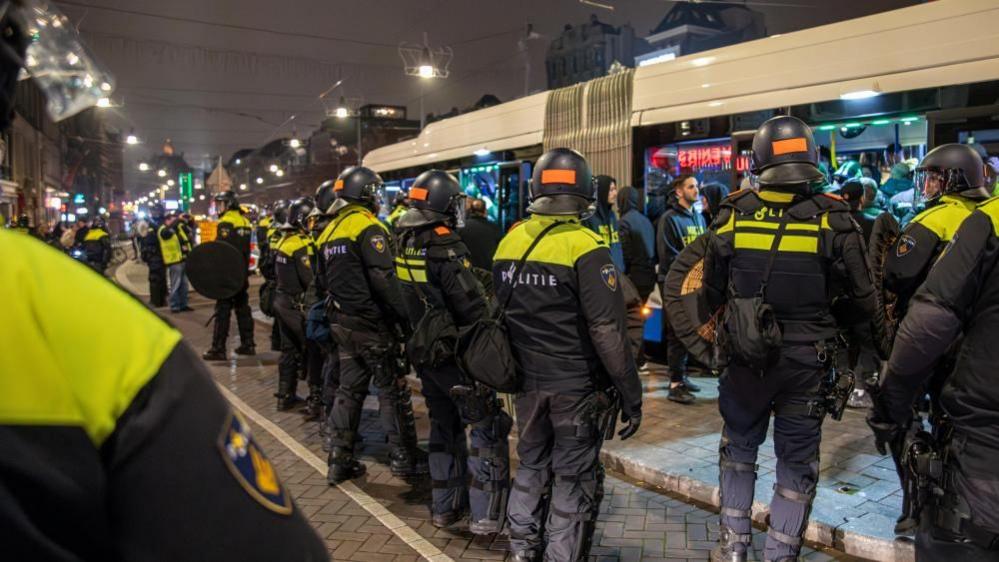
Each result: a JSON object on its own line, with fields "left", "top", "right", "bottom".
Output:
{"left": 916, "top": 419, "right": 999, "bottom": 551}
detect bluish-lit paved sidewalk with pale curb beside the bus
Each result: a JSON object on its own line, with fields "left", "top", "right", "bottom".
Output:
{"left": 603, "top": 370, "right": 915, "bottom": 562}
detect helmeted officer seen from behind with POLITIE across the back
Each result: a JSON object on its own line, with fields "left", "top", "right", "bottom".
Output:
{"left": 493, "top": 148, "right": 642, "bottom": 562}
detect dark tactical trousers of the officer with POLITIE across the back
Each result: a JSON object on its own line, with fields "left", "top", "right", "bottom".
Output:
{"left": 507, "top": 380, "right": 603, "bottom": 562}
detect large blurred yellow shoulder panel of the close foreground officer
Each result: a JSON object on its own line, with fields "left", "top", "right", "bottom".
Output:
{"left": 0, "top": 231, "right": 180, "bottom": 447}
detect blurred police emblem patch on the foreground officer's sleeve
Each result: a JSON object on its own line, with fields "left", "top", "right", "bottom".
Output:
{"left": 218, "top": 412, "right": 292, "bottom": 515}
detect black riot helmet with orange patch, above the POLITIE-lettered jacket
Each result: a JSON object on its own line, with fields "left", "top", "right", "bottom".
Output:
{"left": 527, "top": 148, "right": 596, "bottom": 215}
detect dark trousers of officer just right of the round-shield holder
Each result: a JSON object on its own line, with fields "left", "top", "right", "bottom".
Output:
{"left": 274, "top": 293, "right": 323, "bottom": 397}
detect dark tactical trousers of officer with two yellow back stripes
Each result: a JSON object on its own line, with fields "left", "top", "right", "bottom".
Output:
{"left": 718, "top": 345, "right": 826, "bottom": 560}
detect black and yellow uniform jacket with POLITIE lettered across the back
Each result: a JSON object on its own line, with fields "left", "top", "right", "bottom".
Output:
{"left": 493, "top": 215, "right": 642, "bottom": 415}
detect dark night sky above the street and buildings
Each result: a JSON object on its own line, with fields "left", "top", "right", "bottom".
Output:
{"left": 56, "top": 0, "right": 917, "bottom": 192}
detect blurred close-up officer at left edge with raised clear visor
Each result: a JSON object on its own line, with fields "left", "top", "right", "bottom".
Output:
{"left": 0, "top": 2, "right": 327, "bottom": 562}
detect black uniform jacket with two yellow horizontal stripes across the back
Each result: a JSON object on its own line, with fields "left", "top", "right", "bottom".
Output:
{"left": 704, "top": 190, "right": 875, "bottom": 344}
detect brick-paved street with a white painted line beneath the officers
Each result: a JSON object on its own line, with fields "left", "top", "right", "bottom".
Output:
{"left": 117, "top": 262, "right": 858, "bottom": 562}
